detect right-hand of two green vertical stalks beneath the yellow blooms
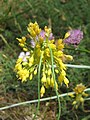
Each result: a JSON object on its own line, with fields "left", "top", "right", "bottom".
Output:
{"left": 49, "top": 47, "right": 61, "bottom": 120}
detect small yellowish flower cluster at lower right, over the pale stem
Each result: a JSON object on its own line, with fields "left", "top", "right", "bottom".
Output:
{"left": 71, "top": 83, "right": 88, "bottom": 109}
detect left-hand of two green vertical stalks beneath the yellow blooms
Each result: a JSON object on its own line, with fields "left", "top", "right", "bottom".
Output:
{"left": 33, "top": 52, "right": 43, "bottom": 120}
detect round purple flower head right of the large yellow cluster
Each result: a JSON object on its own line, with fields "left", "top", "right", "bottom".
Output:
{"left": 64, "top": 30, "right": 83, "bottom": 45}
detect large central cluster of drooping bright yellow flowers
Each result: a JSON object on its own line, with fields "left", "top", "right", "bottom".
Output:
{"left": 15, "top": 22, "right": 73, "bottom": 97}
